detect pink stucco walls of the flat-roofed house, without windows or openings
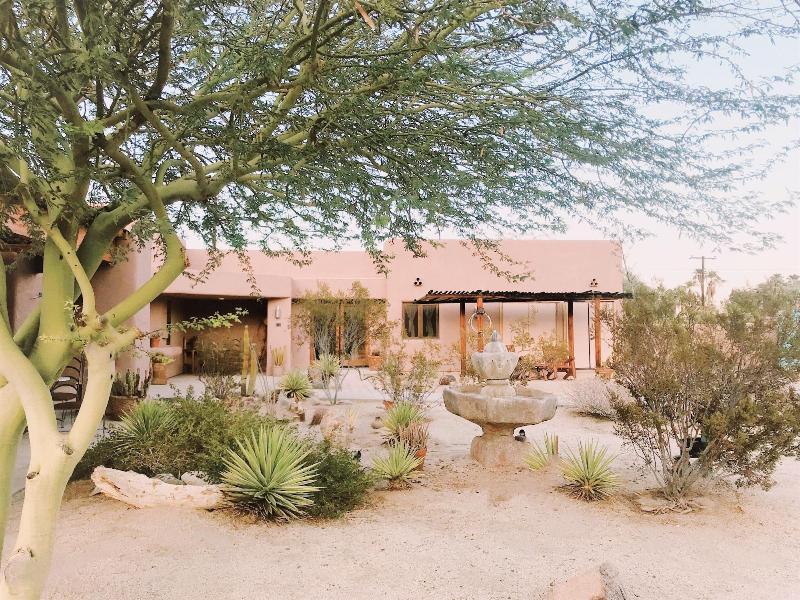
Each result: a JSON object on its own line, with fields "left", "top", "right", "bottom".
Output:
{"left": 158, "top": 240, "right": 623, "bottom": 368}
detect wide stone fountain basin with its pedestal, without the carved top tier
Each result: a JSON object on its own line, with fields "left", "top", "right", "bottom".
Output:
{"left": 443, "top": 380, "right": 557, "bottom": 467}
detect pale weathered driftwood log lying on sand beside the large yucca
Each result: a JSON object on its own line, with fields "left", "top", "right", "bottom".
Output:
{"left": 92, "top": 467, "right": 225, "bottom": 510}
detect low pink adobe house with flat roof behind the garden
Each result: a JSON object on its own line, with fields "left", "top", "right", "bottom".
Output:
{"left": 2, "top": 232, "right": 625, "bottom": 376}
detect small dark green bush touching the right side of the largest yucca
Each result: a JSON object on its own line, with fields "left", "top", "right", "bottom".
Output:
{"left": 306, "top": 442, "right": 372, "bottom": 518}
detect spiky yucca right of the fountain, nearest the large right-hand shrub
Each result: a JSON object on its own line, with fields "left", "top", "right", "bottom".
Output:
{"left": 561, "top": 440, "right": 618, "bottom": 500}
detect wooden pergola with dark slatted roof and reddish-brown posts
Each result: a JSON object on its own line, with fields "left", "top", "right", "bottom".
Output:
{"left": 414, "top": 290, "right": 633, "bottom": 377}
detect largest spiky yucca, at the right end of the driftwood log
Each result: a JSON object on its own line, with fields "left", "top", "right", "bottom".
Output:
{"left": 222, "top": 426, "right": 319, "bottom": 520}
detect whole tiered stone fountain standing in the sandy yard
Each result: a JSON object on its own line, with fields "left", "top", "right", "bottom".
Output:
{"left": 444, "top": 331, "right": 556, "bottom": 467}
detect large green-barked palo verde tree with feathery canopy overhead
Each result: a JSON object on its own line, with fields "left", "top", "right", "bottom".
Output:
{"left": 0, "top": 0, "right": 798, "bottom": 599}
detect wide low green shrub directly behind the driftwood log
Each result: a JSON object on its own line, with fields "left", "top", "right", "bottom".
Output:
{"left": 73, "top": 393, "right": 275, "bottom": 482}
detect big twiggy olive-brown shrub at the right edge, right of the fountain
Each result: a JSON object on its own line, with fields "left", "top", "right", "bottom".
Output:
{"left": 611, "top": 278, "right": 800, "bottom": 503}
